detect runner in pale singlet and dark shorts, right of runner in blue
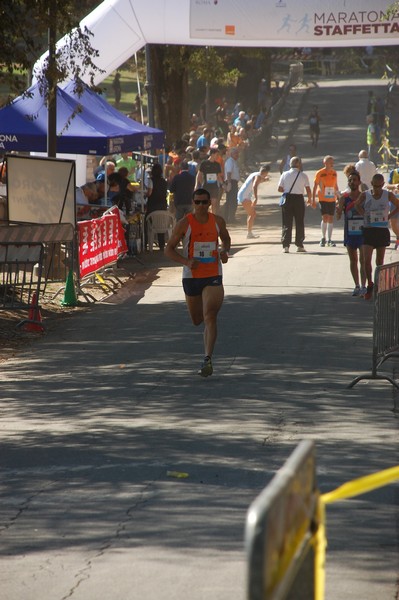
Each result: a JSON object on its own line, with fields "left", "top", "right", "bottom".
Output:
{"left": 355, "top": 173, "right": 399, "bottom": 300}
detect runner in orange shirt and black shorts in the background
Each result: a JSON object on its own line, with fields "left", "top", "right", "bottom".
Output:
{"left": 313, "top": 156, "right": 340, "bottom": 247}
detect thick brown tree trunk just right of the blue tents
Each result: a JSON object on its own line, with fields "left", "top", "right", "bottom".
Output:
{"left": 151, "top": 45, "right": 190, "bottom": 146}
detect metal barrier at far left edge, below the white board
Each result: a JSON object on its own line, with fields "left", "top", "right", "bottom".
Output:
{"left": 0, "top": 243, "right": 44, "bottom": 325}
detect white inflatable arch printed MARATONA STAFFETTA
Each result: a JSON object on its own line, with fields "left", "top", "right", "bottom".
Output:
{"left": 35, "top": 0, "right": 399, "bottom": 83}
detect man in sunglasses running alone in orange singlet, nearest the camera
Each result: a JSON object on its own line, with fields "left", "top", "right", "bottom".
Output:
{"left": 165, "top": 188, "right": 231, "bottom": 377}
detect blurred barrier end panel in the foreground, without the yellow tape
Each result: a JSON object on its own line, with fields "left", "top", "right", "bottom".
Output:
{"left": 245, "top": 440, "right": 318, "bottom": 600}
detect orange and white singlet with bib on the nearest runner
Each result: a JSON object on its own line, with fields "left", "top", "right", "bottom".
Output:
{"left": 183, "top": 213, "right": 222, "bottom": 279}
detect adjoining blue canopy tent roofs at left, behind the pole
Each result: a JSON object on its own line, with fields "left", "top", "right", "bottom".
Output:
{"left": 0, "top": 84, "right": 164, "bottom": 156}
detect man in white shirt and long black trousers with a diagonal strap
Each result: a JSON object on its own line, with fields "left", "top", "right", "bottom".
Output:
{"left": 278, "top": 156, "right": 312, "bottom": 254}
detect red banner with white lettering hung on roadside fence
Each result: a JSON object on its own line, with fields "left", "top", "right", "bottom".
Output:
{"left": 77, "top": 213, "right": 128, "bottom": 277}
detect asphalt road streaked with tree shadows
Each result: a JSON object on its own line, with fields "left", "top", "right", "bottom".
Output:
{"left": 0, "top": 76, "right": 399, "bottom": 600}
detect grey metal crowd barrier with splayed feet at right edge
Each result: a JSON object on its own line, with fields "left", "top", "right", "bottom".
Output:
{"left": 348, "top": 262, "right": 399, "bottom": 389}
